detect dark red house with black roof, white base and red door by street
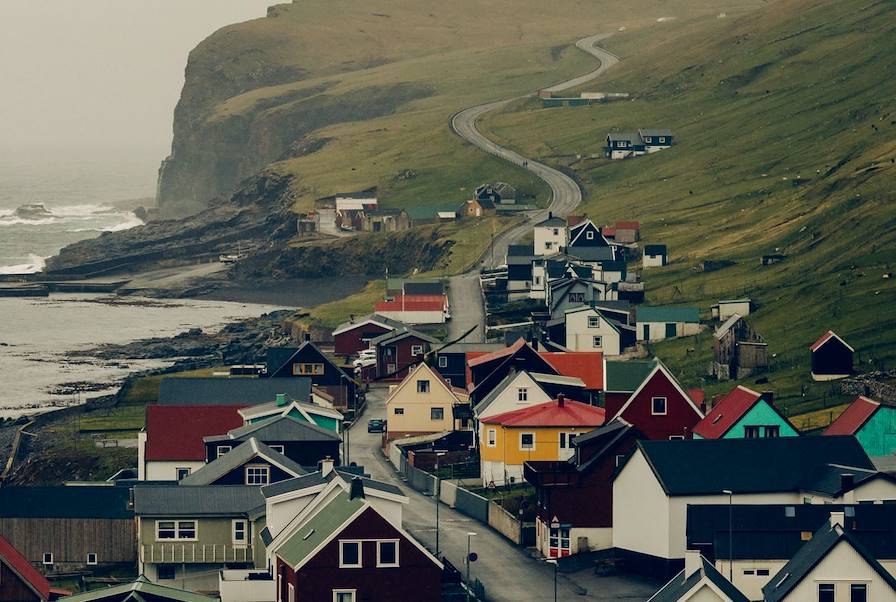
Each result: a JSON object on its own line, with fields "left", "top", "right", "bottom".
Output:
{"left": 523, "top": 420, "right": 643, "bottom": 558}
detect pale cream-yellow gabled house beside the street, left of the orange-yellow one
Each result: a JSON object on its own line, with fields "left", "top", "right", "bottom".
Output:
{"left": 386, "top": 363, "right": 469, "bottom": 440}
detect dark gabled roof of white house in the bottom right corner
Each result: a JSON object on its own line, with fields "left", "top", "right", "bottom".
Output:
{"left": 762, "top": 523, "right": 896, "bottom": 602}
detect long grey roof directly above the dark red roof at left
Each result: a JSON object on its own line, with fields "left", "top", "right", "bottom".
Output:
{"left": 159, "top": 376, "right": 311, "bottom": 405}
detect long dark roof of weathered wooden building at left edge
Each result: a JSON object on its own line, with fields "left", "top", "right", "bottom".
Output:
{"left": 0, "top": 485, "right": 134, "bottom": 519}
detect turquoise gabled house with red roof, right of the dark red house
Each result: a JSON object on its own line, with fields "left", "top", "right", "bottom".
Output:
{"left": 693, "top": 385, "right": 799, "bottom": 439}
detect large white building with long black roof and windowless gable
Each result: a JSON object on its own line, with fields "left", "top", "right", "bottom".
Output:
{"left": 613, "top": 437, "right": 896, "bottom": 575}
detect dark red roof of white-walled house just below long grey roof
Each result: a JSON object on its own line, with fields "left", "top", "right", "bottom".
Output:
{"left": 146, "top": 405, "right": 248, "bottom": 461}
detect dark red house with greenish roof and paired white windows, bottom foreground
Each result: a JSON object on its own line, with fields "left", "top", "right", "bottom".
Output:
{"left": 275, "top": 478, "right": 444, "bottom": 602}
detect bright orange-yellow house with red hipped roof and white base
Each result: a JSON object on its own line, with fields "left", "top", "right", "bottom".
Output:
{"left": 479, "top": 394, "right": 606, "bottom": 487}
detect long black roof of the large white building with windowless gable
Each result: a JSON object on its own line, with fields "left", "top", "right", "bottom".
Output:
{"left": 638, "top": 437, "right": 874, "bottom": 495}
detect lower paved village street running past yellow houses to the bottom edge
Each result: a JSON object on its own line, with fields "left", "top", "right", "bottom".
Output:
{"left": 349, "top": 388, "right": 657, "bottom": 602}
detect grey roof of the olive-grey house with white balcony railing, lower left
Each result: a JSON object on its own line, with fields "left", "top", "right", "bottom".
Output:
{"left": 134, "top": 483, "right": 264, "bottom": 516}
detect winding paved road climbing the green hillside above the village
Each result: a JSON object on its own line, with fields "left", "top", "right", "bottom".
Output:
{"left": 448, "top": 33, "right": 619, "bottom": 343}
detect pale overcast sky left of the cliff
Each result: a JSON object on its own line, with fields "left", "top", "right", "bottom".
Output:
{"left": 0, "top": 0, "right": 277, "bottom": 159}
